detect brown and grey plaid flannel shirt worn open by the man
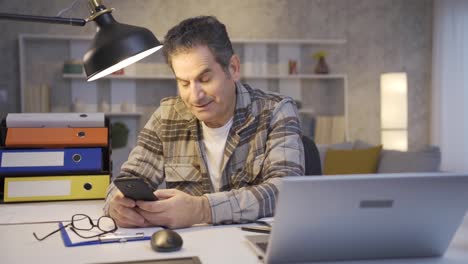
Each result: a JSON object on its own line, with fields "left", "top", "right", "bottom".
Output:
{"left": 104, "top": 82, "right": 304, "bottom": 224}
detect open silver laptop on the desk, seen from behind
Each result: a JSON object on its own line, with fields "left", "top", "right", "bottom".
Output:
{"left": 246, "top": 173, "right": 468, "bottom": 263}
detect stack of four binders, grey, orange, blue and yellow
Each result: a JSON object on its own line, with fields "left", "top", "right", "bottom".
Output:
{"left": 0, "top": 113, "right": 111, "bottom": 202}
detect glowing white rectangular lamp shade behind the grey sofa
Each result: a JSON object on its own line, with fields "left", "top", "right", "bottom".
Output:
{"left": 380, "top": 72, "right": 408, "bottom": 150}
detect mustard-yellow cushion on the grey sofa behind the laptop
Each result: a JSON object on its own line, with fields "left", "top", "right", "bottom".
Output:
{"left": 323, "top": 145, "right": 382, "bottom": 174}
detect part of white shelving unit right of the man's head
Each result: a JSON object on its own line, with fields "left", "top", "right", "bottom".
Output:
{"left": 233, "top": 39, "right": 349, "bottom": 141}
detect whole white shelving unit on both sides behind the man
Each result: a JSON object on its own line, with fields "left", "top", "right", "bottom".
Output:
{"left": 19, "top": 34, "right": 348, "bottom": 175}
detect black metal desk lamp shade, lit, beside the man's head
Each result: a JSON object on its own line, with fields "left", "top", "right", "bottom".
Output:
{"left": 83, "top": 9, "right": 162, "bottom": 81}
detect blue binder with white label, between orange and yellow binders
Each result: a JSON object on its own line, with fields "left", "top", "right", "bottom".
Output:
{"left": 0, "top": 148, "right": 103, "bottom": 175}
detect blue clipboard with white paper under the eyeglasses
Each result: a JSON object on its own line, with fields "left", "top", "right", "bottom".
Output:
{"left": 59, "top": 222, "right": 155, "bottom": 247}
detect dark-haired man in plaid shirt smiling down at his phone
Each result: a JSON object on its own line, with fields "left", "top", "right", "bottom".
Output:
{"left": 104, "top": 16, "right": 304, "bottom": 228}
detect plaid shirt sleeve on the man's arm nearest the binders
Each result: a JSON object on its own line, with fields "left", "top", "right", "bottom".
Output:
{"left": 104, "top": 109, "right": 164, "bottom": 215}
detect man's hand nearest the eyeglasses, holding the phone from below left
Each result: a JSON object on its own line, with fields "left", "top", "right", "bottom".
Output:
{"left": 109, "top": 191, "right": 150, "bottom": 227}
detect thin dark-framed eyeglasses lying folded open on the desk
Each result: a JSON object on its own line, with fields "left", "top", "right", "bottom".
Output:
{"left": 33, "top": 214, "right": 117, "bottom": 241}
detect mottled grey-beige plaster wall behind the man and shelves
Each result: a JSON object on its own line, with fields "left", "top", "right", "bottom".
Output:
{"left": 0, "top": 0, "right": 433, "bottom": 149}
